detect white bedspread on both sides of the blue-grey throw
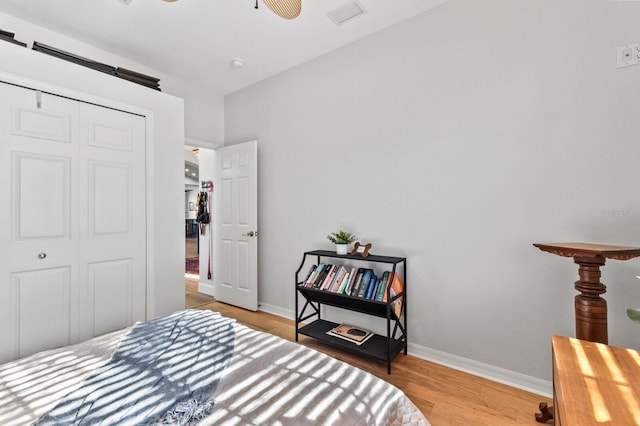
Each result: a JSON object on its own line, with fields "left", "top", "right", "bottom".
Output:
{"left": 0, "top": 311, "right": 429, "bottom": 426}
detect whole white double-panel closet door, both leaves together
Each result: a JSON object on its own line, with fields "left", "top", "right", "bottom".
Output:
{"left": 0, "top": 83, "right": 146, "bottom": 362}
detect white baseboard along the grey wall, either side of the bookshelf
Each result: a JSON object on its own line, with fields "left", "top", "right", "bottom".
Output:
{"left": 252, "top": 302, "right": 553, "bottom": 398}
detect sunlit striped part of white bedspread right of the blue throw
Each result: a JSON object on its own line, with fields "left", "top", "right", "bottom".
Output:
{"left": 203, "top": 324, "right": 429, "bottom": 426}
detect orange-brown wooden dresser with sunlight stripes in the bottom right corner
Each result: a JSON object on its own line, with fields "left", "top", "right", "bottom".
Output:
{"left": 552, "top": 333, "right": 640, "bottom": 426}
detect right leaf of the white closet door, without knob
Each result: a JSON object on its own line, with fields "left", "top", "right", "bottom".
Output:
{"left": 78, "top": 103, "right": 146, "bottom": 337}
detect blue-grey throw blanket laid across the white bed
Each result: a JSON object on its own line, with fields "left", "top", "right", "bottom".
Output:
{"left": 34, "top": 310, "right": 235, "bottom": 425}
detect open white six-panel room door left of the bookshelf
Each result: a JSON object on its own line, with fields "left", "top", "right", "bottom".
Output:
{"left": 214, "top": 141, "right": 258, "bottom": 311}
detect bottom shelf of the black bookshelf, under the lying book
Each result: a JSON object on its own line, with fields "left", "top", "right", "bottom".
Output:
{"left": 298, "top": 319, "right": 404, "bottom": 362}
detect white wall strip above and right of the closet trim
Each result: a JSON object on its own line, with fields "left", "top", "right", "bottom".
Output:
{"left": 0, "top": 37, "right": 184, "bottom": 317}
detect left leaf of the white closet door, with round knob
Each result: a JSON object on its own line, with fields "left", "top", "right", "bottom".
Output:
{"left": 0, "top": 84, "right": 80, "bottom": 362}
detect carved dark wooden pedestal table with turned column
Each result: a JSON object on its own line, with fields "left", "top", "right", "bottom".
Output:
{"left": 534, "top": 243, "right": 640, "bottom": 423}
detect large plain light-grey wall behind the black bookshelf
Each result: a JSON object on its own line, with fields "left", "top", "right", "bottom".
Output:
{"left": 225, "top": 0, "right": 640, "bottom": 383}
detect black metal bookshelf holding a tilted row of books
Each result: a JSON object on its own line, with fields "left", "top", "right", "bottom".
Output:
{"left": 295, "top": 250, "right": 408, "bottom": 374}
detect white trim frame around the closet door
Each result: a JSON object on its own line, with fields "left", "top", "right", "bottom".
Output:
{"left": 0, "top": 71, "right": 156, "bottom": 320}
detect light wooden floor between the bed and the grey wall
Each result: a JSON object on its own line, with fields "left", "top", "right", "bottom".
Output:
{"left": 185, "top": 278, "right": 552, "bottom": 426}
